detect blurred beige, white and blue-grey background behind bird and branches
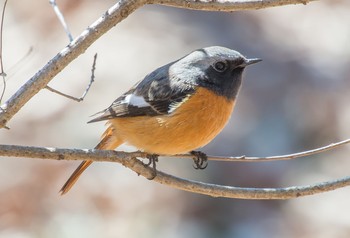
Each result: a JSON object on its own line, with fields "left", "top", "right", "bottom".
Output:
{"left": 0, "top": 0, "right": 350, "bottom": 238}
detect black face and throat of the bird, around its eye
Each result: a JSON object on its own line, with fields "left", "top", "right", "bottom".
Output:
{"left": 197, "top": 58, "right": 244, "bottom": 99}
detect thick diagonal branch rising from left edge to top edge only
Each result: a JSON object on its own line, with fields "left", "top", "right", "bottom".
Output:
{"left": 0, "top": 0, "right": 147, "bottom": 128}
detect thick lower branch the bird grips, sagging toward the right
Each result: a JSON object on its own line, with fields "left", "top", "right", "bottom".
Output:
{"left": 0, "top": 145, "right": 350, "bottom": 199}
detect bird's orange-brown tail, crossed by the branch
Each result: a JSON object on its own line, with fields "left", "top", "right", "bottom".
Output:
{"left": 60, "top": 126, "right": 123, "bottom": 195}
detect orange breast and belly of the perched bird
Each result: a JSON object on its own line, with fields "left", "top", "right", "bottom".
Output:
{"left": 110, "top": 88, "right": 234, "bottom": 154}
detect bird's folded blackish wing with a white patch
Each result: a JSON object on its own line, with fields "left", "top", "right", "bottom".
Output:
{"left": 89, "top": 65, "right": 194, "bottom": 123}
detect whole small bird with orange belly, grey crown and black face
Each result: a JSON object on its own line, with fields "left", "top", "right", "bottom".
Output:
{"left": 60, "top": 46, "right": 261, "bottom": 195}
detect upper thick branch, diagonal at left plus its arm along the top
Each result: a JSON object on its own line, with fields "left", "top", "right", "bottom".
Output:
{"left": 0, "top": 0, "right": 315, "bottom": 128}
